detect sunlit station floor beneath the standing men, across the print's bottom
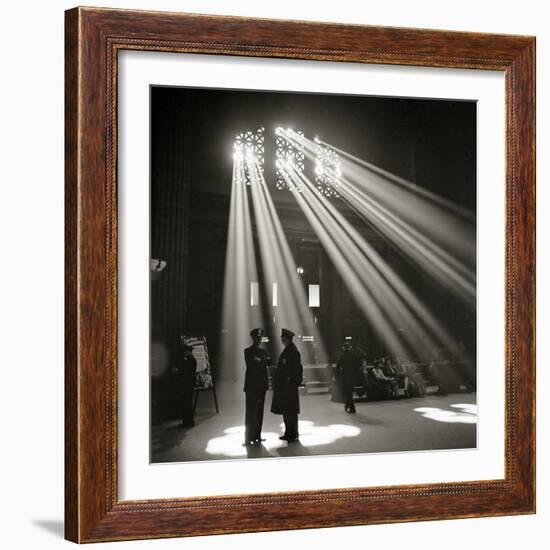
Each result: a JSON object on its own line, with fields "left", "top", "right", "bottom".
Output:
{"left": 151, "top": 382, "right": 477, "bottom": 462}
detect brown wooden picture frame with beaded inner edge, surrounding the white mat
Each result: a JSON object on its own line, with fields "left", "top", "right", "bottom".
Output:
{"left": 65, "top": 8, "right": 535, "bottom": 543}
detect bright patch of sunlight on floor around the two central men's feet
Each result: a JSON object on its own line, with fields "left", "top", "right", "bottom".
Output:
{"left": 206, "top": 420, "right": 361, "bottom": 457}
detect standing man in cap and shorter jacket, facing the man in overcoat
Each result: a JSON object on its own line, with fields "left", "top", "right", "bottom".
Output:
{"left": 244, "top": 328, "right": 269, "bottom": 445}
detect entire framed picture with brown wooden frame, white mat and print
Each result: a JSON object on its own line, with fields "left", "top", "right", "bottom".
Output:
{"left": 65, "top": 8, "right": 535, "bottom": 542}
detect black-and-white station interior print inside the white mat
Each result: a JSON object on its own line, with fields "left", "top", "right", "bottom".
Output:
{"left": 149, "top": 86, "right": 482, "bottom": 463}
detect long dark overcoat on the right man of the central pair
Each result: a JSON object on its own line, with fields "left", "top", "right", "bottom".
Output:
{"left": 271, "top": 343, "right": 303, "bottom": 414}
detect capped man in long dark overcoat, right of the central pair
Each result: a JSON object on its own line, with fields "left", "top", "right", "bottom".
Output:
{"left": 271, "top": 328, "right": 303, "bottom": 443}
